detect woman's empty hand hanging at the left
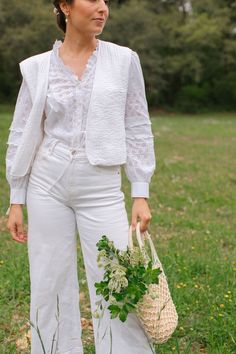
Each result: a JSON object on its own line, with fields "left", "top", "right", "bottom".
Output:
{"left": 7, "top": 204, "right": 27, "bottom": 243}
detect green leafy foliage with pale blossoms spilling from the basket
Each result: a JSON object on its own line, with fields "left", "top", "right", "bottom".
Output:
{"left": 93, "top": 235, "right": 162, "bottom": 322}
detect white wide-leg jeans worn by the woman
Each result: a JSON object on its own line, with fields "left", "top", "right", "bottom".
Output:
{"left": 26, "top": 138, "right": 155, "bottom": 354}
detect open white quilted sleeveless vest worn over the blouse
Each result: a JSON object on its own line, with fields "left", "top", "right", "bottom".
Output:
{"left": 11, "top": 39, "right": 132, "bottom": 177}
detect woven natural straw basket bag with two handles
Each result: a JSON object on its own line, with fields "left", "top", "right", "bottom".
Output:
{"left": 128, "top": 222, "right": 178, "bottom": 344}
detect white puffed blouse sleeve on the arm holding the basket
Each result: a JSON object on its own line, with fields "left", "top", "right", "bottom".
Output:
{"left": 124, "top": 51, "right": 156, "bottom": 198}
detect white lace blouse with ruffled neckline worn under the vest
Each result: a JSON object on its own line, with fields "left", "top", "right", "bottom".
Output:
{"left": 6, "top": 40, "right": 156, "bottom": 204}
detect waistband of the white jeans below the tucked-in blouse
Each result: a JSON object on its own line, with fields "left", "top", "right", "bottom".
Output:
{"left": 40, "top": 138, "right": 87, "bottom": 159}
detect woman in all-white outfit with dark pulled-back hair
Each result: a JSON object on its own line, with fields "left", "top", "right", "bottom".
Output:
{"left": 6, "top": 0, "right": 155, "bottom": 354}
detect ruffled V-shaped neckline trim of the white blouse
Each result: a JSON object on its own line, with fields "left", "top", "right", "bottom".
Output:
{"left": 54, "top": 38, "right": 100, "bottom": 83}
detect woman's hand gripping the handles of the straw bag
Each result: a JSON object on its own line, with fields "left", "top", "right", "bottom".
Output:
{"left": 131, "top": 197, "right": 152, "bottom": 233}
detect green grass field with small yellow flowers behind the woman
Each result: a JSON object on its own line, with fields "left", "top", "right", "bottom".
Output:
{"left": 0, "top": 107, "right": 236, "bottom": 354}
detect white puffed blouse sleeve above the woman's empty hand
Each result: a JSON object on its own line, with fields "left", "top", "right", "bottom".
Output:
{"left": 6, "top": 78, "right": 32, "bottom": 215}
